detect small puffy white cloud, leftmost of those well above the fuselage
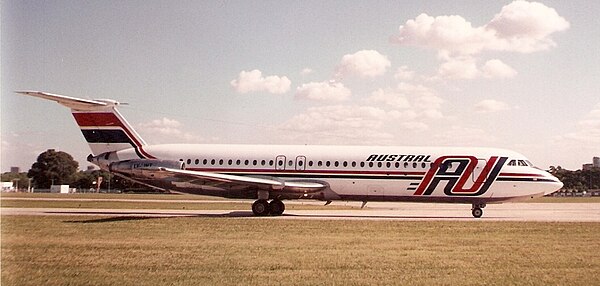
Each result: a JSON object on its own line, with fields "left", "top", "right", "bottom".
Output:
{"left": 230, "top": 70, "right": 292, "bottom": 94}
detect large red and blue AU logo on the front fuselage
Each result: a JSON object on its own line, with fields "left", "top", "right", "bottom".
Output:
{"left": 414, "top": 156, "right": 508, "bottom": 196}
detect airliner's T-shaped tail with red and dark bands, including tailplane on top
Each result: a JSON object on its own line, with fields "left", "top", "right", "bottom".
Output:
{"left": 17, "top": 91, "right": 153, "bottom": 158}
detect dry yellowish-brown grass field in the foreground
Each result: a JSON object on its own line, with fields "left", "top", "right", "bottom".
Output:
{"left": 1, "top": 216, "right": 600, "bottom": 285}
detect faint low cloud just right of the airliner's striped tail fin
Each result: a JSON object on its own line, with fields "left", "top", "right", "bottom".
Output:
{"left": 138, "top": 117, "right": 201, "bottom": 143}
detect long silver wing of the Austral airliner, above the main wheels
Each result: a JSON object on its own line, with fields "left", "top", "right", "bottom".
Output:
{"left": 161, "top": 167, "right": 327, "bottom": 193}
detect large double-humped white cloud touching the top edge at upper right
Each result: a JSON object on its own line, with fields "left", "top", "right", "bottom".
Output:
{"left": 390, "top": 1, "right": 569, "bottom": 55}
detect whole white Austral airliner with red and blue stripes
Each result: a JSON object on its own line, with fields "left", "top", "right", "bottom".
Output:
{"left": 17, "top": 91, "right": 563, "bottom": 218}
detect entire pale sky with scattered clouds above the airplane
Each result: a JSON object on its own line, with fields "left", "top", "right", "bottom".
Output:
{"left": 0, "top": 0, "right": 600, "bottom": 171}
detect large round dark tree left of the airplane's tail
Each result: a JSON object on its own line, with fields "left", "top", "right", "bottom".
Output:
{"left": 27, "top": 149, "right": 79, "bottom": 188}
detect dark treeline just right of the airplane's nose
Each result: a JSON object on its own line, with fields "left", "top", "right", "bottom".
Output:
{"left": 549, "top": 166, "right": 600, "bottom": 192}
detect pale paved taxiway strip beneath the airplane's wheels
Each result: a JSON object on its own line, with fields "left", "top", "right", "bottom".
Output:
{"left": 0, "top": 203, "right": 600, "bottom": 222}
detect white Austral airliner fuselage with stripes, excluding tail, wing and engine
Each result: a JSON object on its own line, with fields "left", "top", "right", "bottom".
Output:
{"left": 97, "top": 144, "right": 562, "bottom": 204}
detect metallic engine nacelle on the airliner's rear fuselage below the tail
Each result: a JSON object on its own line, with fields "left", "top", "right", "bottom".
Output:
{"left": 108, "top": 159, "right": 185, "bottom": 178}
